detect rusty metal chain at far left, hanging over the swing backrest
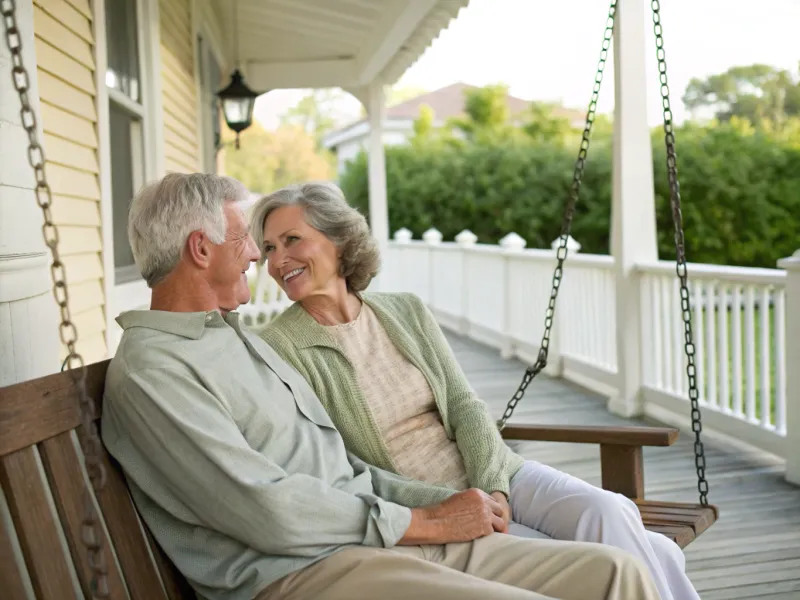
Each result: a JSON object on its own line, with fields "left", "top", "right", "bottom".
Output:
{"left": 0, "top": 0, "right": 109, "bottom": 598}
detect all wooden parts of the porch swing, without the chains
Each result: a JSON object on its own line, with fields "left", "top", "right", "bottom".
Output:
{"left": 0, "top": 360, "right": 717, "bottom": 600}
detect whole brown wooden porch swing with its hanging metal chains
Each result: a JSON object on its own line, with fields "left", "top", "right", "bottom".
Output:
{"left": 0, "top": 0, "right": 718, "bottom": 600}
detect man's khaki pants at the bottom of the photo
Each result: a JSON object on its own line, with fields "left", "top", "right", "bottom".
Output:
{"left": 258, "top": 533, "right": 659, "bottom": 600}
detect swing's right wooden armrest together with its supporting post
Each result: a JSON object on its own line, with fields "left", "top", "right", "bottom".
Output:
{"left": 502, "top": 425, "right": 679, "bottom": 500}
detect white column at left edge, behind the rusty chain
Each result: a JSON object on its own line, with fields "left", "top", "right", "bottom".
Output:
{"left": 0, "top": 0, "right": 59, "bottom": 386}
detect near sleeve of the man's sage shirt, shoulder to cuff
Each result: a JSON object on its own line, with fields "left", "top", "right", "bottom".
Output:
{"left": 104, "top": 369, "right": 411, "bottom": 556}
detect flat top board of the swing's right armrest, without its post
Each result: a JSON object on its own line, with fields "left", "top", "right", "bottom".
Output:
{"left": 502, "top": 425, "right": 679, "bottom": 446}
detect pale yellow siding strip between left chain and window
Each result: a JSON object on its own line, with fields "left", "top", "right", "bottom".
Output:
{"left": 33, "top": 0, "right": 107, "bottom": 363}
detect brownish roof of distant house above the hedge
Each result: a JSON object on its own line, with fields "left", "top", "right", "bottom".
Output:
{"left": 323, "top": 82, "right": 585, "bottom": 148}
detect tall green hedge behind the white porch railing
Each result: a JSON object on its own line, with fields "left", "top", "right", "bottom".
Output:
{"left": 340, "top": 125, "right": 800, "bottom": 267}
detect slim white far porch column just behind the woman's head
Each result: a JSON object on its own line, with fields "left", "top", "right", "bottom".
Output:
{"left": 367, "top": 83, "right": 389, "bottom": 251}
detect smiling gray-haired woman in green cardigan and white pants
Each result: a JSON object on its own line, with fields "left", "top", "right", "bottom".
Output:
{"left": 251, "top": 183, "right": 699, "bottom": 600}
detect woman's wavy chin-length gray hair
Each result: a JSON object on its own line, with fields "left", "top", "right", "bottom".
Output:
{"left": 250, "top": 181, "right": 380, "bottom": 292}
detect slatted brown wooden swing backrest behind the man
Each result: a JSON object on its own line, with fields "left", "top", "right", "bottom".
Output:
{"left": 0, "top": 361, "right": 196, "bottom": 600}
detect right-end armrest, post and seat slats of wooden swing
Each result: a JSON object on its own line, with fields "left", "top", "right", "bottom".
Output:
{"left": 502, "top": 425, "right": 719, "bottom": 548}
